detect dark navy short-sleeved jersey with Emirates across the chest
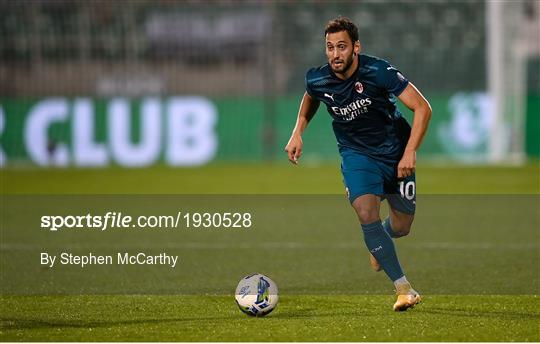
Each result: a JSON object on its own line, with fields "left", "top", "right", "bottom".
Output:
{"left": 306, "top": 55, "right": 410, "bottom": 163}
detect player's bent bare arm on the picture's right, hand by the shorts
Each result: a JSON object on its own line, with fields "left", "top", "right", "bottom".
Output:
{"left": 397, "top": 82, "right": 431, "bottom": 178}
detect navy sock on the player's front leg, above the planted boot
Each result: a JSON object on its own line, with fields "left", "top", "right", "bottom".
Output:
{"left": 362, "top": 220, "right": 404, "bottom": 281}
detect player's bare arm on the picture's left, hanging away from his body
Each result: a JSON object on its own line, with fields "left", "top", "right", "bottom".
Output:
{"left": 285, "top": 92, "right": 320, "bottom": 165}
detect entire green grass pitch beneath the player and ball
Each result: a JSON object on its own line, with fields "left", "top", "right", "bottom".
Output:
{"left": 0, "top": 163, "right": 540, "bottom": 341}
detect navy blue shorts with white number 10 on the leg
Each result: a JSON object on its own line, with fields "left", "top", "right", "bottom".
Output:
{"left": 340, "top": 148, "right": 416, "bottom": 215}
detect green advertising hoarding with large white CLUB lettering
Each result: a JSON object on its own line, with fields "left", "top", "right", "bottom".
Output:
{"left": 0, "top": 93, "right": 540, "bottom": 167}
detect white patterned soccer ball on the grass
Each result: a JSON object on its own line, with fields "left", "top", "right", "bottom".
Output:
{"left": 235, "top": 274, "right": 279, "bottom": 317}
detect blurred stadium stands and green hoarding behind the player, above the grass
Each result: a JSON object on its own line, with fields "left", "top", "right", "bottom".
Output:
{"left": 0, "top": 0, "right": 540, "bottom": 167}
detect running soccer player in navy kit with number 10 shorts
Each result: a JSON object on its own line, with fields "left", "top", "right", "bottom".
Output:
{"left": 285, "top": 17, "right": 431, "bottom": 311}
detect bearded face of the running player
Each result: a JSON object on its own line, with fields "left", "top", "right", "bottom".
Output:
{"left": 326, "top": 31, "right": 355, "bottom": 74}
